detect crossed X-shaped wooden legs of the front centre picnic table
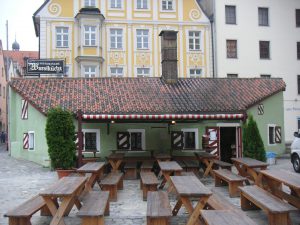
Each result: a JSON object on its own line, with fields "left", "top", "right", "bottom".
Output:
{"left": 181, "top": 196, "right": 209, "bottom": 225}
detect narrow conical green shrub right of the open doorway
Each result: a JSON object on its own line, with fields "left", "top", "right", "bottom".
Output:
{"left": 243, "top": 115, "right": 266, "bottom": 162}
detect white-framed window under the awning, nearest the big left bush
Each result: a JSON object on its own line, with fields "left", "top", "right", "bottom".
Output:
{"left": 82, "top": 129, "right": 100, "bottom": 152}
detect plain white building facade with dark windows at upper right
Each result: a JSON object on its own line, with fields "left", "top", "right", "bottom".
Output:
{"left": 199, "top": 0, "right": 300, "bottom": 143}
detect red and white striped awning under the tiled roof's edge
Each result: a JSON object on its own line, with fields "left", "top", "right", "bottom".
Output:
{"left": 82, "top": 114, "right": 244, "bottom": 120}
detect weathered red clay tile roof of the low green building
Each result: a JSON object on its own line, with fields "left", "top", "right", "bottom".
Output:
{"left": 10, "top": 78, "right": 285, "bottom": 114}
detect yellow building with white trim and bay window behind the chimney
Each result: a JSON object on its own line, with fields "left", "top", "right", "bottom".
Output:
{"left": 33, "top": 0, "right": 212, "bottom": 78}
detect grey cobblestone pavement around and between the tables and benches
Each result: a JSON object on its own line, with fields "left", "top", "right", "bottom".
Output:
{"left": 0, "top": 145, "right": 300, "bottom": 225}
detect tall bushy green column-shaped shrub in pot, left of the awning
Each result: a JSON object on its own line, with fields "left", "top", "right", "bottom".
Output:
{"left": 46, "top": 108, "right": 76, "bottom": 169}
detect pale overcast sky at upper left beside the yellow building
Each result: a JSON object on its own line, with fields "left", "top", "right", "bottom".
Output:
{"left": 0, "top": 0, "right": 44, "bottom": 51}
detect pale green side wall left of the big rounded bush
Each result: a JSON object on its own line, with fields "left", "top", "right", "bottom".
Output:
{"left": 9, "top": 91, "right": 50, "bottom": 166}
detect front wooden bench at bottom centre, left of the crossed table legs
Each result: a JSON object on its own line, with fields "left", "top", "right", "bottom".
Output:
{"left": 147, "top": 191, "right": 172, "bottom": 225}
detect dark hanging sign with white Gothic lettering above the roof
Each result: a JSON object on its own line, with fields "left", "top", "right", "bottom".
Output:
{"left": 26, "top": 59, "right": 65, "bottom": 76}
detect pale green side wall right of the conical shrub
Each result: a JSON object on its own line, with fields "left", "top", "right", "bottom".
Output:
{"left": 247, "top": 92, "right": 285, "bottom": 155}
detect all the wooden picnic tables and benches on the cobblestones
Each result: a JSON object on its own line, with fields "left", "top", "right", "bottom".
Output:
{"left": 5, "top": 152, "right": 300, "bottom": 225}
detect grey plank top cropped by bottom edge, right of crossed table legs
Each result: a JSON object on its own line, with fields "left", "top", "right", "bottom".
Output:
{"left": 201, "top": 210, "right": 257, "bottom": 225}
